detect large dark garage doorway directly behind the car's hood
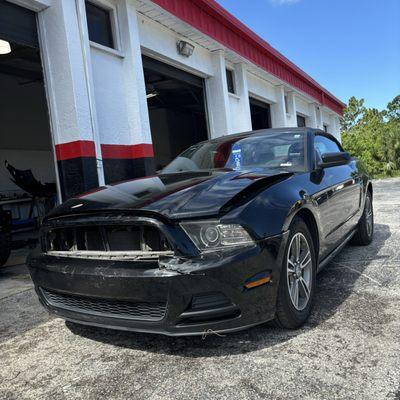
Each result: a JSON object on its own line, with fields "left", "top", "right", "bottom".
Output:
{"left": 143, "top": 56, "right": 208, "bottom": 170}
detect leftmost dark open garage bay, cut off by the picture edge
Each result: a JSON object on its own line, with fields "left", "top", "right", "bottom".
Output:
{"left": 0, "top": 0, "right": 57, "bottom": 241}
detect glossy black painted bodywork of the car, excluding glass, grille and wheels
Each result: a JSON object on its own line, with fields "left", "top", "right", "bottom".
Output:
{"left": 29, "top": 128, "right": 372, "bottom": 335}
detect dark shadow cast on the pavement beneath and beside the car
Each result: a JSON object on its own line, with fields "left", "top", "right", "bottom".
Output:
{"left": 66, "top": 224, "right": 391, "bottom": 358}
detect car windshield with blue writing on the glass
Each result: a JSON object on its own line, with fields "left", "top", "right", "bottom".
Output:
{"left": 162, "top": 132, "right": 305, "bottom": 173}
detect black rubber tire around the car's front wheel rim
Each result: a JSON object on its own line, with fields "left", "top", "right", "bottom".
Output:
{"left": 273, "top": 217, "right": 317, "bottom": 329}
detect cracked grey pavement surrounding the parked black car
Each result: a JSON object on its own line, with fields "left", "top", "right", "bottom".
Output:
{"left": 0, "top": 179, "right": 400, "bottom": 400}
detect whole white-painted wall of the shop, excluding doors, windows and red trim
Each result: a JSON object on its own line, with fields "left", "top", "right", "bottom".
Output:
{"left": 12, "top": 0, "right": 339, "bottom": 194}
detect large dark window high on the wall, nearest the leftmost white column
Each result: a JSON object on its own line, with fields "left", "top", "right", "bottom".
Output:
{"left": 85, "top": 1, "right": 114, "bottom": 48}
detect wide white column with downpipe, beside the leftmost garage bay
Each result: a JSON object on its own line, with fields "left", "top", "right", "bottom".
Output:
{"left": 38, "top": 0, "right": 104, "bottom": 198}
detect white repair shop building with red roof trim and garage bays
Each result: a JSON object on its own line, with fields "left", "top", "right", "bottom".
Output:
{"left": 0, "top": 0, "right": 344, "bottom": 199}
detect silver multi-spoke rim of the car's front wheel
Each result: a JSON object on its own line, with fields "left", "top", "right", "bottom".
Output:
{"left": 286, "top": 232, "right": 312, "bottom": 311}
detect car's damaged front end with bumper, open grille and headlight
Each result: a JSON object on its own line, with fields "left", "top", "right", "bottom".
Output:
{"left": 28, "top": 213, "right": 286, "bottom": 335}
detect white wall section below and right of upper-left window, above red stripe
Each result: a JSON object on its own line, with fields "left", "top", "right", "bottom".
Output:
{"left": 90, "top": 1, "right": 151, "bottom": 145}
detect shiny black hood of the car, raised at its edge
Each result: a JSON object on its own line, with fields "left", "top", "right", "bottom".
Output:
{"left": 47, "top": 170, "right": 291, "bottom": 219}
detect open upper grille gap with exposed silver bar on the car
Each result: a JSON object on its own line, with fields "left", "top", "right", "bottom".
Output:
{"left": 42, "top": 224, "right": 172, "bottom": 258}
